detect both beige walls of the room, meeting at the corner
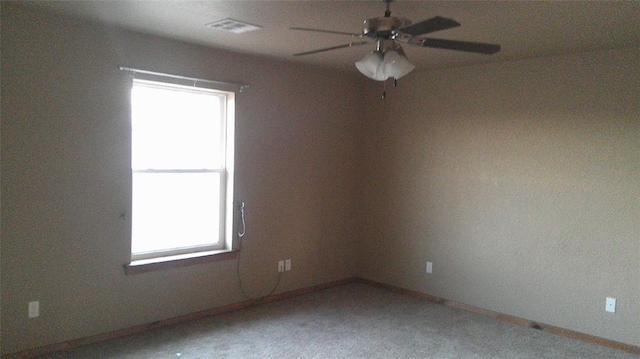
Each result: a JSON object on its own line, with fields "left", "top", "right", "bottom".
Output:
{"left": 1, "top": 2, "right": 640, "bottom": 353}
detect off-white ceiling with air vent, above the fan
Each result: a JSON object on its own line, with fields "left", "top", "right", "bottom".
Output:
{"left": 24, "top": 0, "right": 640, "bottom": 72}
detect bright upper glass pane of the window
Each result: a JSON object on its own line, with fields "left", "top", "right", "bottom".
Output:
{"left": 131, "top": 84, "right": 224, "bottom": 169}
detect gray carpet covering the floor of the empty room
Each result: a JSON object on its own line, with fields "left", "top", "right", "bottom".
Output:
{"left": 40, "top": 283, "right": 639, "bottom": 359}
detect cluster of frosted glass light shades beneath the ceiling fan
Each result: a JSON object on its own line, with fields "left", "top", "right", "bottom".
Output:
{"left": 356, "top": 50, "right": 415, "bottom": 81}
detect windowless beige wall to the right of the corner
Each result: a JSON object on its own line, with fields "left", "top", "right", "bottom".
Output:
{"left": 359, "top": 49, "right": 640, "bottom": 345}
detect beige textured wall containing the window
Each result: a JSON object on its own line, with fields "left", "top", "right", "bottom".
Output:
{"left": 1, "top": 2, "right": 360, "bottom": 353}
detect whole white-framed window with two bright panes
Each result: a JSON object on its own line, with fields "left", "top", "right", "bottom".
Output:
{"left": 131, "top": 79, "right": 234, "bottom": 261}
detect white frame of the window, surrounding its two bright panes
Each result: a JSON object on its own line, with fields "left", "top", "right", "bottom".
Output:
{"left": 131, "top": 75, "right": 235, "bottom": 263}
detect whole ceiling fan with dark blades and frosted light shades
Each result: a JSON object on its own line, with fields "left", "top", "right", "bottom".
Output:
{"left": 290, "top": 0, "right": 500, "bottom": 84}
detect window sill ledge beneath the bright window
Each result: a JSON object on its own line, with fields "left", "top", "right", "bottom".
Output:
{"left": 124, "top": 250, "right": 238, "bottom": 275}
